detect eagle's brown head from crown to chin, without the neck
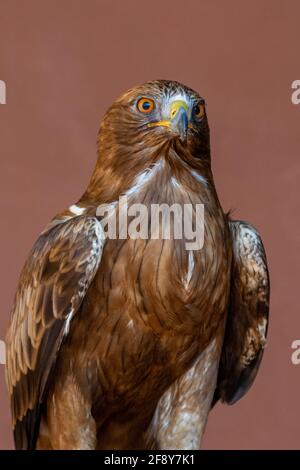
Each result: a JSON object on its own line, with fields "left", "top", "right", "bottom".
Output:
{"left": 99, "top": 80, "right": 209, "bottom": 156}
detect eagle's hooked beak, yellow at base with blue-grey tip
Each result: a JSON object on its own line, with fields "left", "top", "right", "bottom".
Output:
{"left": 148, "top": 100, "right": 192, "bottom": 142}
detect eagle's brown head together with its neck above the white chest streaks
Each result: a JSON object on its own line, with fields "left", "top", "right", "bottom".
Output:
{"left": 82, "top": 80, "right": 210, "bottom": 204}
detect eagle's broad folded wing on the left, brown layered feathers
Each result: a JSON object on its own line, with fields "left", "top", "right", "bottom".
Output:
{"left": 6, "top": 216, "right": 104, "bottom": 449}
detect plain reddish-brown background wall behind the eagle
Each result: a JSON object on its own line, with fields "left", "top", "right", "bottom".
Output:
{"left": 0, "top": 0, "right": 300, "bottom": 449}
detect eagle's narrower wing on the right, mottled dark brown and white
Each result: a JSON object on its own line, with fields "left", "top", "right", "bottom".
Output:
{"left": 214, "top": 221, "right": 270, "bottom": 404}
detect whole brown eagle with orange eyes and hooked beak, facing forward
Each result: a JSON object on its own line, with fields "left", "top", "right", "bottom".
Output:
{"left": 6, "top": 80, "right": 269, "bottom": 450}
